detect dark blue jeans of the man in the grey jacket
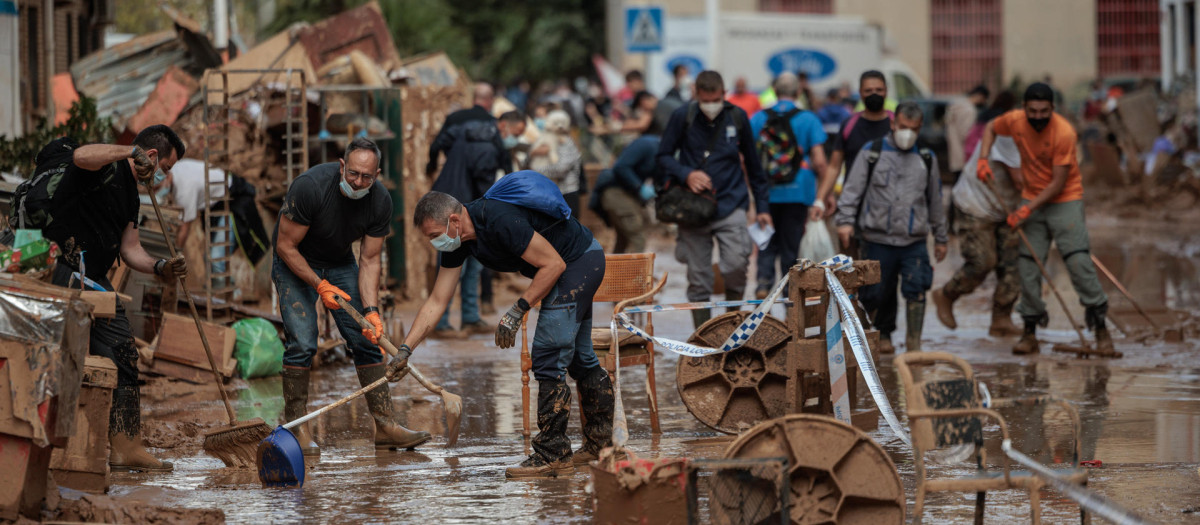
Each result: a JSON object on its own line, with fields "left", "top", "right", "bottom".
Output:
{"left": 859, "top": 241, "right": 934, "bottom": 336}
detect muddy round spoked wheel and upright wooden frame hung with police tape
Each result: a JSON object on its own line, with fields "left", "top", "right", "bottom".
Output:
{"left": 676, "top": 260, "right": 880, "bottom": 434}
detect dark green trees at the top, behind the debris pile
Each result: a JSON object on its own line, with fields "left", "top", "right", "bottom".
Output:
{"left": 268, "top": 0, "right": 605, "bottom": 83}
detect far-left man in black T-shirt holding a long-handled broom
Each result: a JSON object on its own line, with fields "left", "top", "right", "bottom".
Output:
{"left": 42, "top": 125, "right": 187, "bottom": 471}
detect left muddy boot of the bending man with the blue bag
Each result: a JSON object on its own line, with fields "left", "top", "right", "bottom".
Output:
{"left": 504, "top": 381, "right": 576, "bottom": 479}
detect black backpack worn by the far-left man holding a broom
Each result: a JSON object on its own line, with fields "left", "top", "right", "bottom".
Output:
{"left": 8, "top": 137, "right": 79, "bottom": 230}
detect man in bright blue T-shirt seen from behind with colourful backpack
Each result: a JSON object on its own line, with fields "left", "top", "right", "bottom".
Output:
{"left": 750, "top": 73, "right": 826, "bottom": 298}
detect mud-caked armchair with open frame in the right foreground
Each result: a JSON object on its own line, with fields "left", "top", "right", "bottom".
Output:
{"left": 895, "top": 352, "right": 1090, "bottom": 524}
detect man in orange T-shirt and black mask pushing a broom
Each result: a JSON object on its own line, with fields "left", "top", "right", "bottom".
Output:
{"left": 977, "top": 83, "right": 1114, "bottom": 354}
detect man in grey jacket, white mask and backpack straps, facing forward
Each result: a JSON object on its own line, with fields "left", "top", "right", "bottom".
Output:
{"left": 834, "top": 102, "right": 947, "bottom": 354}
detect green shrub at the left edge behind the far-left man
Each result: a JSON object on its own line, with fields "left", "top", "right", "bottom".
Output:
{"left": 0, "top": 97, "right": 113, "bottom": 176}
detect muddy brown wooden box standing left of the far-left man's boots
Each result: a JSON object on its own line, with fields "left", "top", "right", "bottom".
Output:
{"left": 50, "top": 356, "right": 116, "bottom": 494}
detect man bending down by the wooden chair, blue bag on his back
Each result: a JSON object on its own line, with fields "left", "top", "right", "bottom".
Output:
{"left": 402, "top": 186, "right": 613, "bottom": 478}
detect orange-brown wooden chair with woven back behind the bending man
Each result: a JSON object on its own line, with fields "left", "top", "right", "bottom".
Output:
{"left": 521, "top": 253, "right": 666, "bottom": 438}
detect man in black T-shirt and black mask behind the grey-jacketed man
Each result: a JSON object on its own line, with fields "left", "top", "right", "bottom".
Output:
{"left": 809, "top": 70, "right": 892, "bottom": 230}
